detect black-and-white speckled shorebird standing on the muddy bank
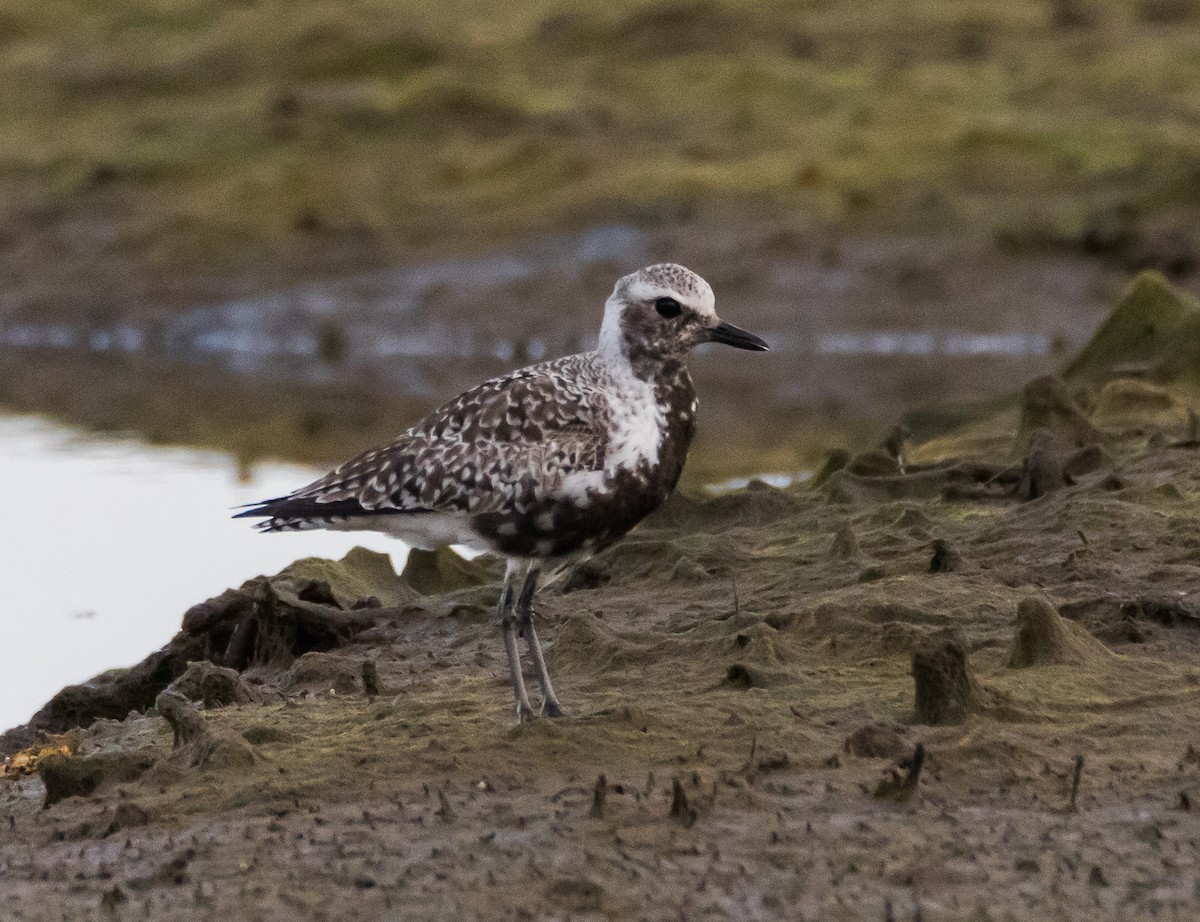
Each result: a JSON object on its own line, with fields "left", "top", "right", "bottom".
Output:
{"left": 238, "top": 263, "right": 768, "bottom": 722}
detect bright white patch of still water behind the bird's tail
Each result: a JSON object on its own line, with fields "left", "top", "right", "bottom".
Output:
{"left": 0, "top": 417, "right": 407, "bottom": 730}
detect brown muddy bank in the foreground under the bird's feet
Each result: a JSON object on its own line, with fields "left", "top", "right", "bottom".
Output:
{"left": 0, "top": 270, "right": 1200, "bottom": 920}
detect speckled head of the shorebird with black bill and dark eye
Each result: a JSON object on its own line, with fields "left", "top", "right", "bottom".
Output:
{"left": 600, "top": 263, "right": 768, "bottom": 371}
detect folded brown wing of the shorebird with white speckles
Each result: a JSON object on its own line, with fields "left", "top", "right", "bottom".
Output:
{"left": 280, "top": 357, "right": 610, "bottom": 516}
